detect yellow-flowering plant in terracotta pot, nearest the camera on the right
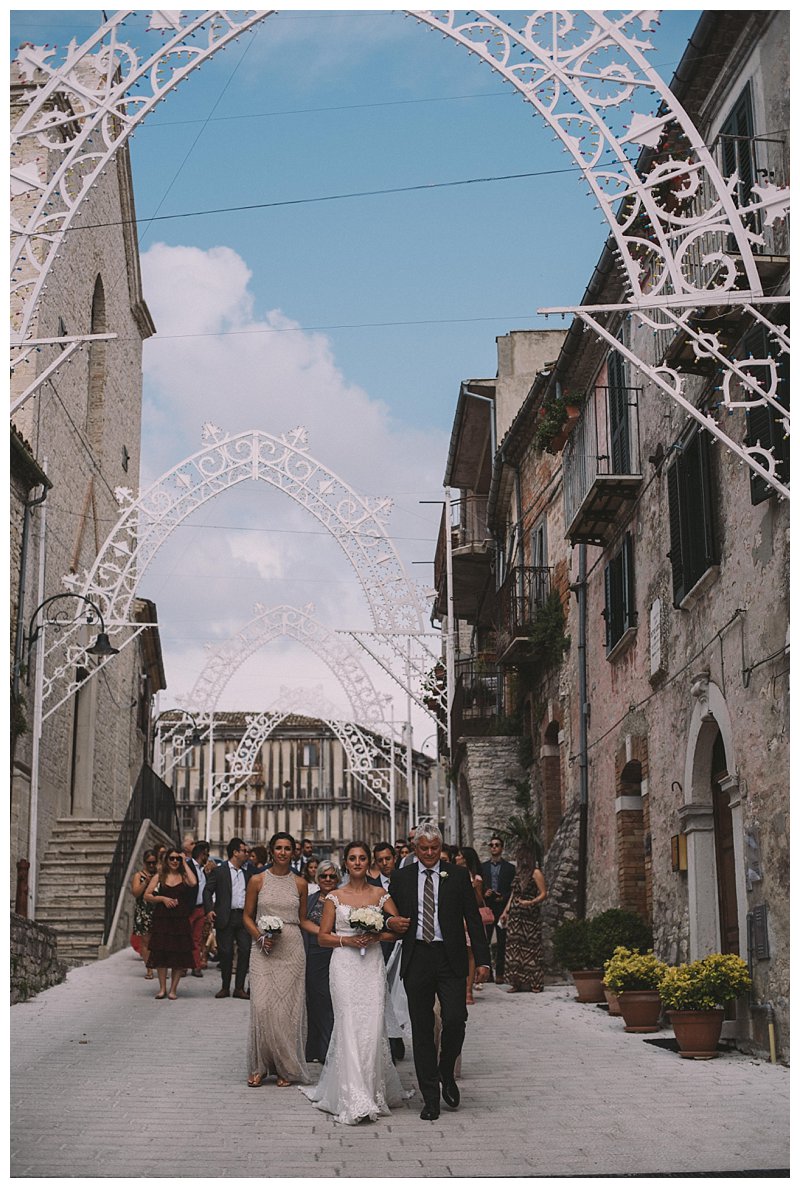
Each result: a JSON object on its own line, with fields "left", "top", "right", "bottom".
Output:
{"left": 659, "top": 953, "right": 751, "bottom": 1060}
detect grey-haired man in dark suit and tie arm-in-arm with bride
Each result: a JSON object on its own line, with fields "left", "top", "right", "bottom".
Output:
{"left": 386, "top": 824, "right": 490, "bottom": 1121}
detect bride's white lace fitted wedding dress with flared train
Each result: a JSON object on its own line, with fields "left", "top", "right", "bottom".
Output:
{"left": 298, "top": 893, "right": 414, "bottom": 1126}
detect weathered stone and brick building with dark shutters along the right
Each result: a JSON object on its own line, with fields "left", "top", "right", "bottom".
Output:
{"left": 430, "top": 12, "right": 789, "bottom": 1059}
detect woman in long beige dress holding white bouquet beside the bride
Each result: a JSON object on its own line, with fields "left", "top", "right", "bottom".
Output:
{"left": 242, "top": 833, "right": 314, "bottom": 1089}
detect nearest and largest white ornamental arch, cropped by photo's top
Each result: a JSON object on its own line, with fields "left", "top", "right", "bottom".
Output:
{"left": 12, "top": 10, "right": 789, "bottom": 497}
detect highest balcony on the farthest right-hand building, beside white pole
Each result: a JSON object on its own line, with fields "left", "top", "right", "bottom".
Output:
{"left": 434, "top": 495, "right": 493, "bottom": 624}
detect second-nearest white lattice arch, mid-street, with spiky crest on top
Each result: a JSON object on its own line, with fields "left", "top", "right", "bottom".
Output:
{"left": 43, "top": 423, "right": 424, "bottom": 718}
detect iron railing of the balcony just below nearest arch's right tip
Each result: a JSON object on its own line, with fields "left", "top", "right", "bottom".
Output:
{"left": 563, "top": 387, "right": 642, "bottom": 525}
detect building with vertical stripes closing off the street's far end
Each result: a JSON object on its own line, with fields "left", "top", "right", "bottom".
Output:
{"left": 157, "top": 712, "right": 436, "bottom": 860}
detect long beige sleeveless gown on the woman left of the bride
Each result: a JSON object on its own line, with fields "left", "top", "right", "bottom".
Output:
{"left": 247, "top": 870, "right": 311, "bottom": 1085}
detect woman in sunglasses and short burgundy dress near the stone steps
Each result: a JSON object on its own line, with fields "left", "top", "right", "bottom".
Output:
{"left": 144, "top": 847, "right": 197, "bottom": 999}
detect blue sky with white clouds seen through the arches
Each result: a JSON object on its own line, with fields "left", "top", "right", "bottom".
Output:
{"left": 11, "top": 8, "right": 699, "bottom": 733}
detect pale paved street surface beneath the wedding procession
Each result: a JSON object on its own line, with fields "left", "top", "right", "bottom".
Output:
{"left": 11, "top": 949, "right": 789, "bottom": 1178}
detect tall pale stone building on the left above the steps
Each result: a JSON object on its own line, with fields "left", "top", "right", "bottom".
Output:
{"left": 10, "top": 65, "right": 165, "bottom": 911}
